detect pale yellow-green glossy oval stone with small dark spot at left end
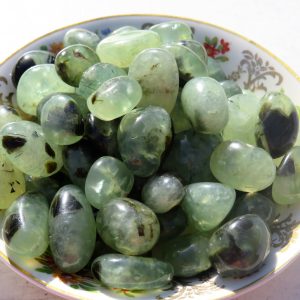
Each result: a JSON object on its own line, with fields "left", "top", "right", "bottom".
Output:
{"left": 87, "top": 76, "right": 142, "bottom": 121}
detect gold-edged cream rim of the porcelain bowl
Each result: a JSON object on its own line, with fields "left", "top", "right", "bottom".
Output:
{"left": 0, "top": 13, "right": 300, "bottom": 300}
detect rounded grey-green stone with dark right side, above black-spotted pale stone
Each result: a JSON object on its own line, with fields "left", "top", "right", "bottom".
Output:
{"left": 40, "top": 93, "right": 84, "bottom": 145}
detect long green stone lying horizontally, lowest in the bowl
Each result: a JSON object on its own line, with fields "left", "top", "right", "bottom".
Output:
{"left": 92, "top": 254, "right": 173, "bottom": 290}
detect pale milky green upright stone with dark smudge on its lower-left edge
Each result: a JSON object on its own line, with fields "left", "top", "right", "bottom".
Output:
{"left": 181, "top": 77, "right": 228, "bottom": 134}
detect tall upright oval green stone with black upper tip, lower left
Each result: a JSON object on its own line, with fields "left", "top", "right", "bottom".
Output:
{"left": 49, "top": 185, "right": 96, "bottom": 273}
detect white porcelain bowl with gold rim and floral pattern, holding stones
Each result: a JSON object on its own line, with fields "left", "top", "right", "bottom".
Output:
{"left": 0, "top": 15, "right": 300, "bottom": 300}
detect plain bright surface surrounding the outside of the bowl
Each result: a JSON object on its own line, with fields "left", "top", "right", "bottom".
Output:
{"left": 0, "top": 0, "right": 300, "bottom": 300}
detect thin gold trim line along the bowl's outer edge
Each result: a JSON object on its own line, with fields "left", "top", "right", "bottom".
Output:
{"left": 0, "top": 14, "right": 300, "bottom": 300}
